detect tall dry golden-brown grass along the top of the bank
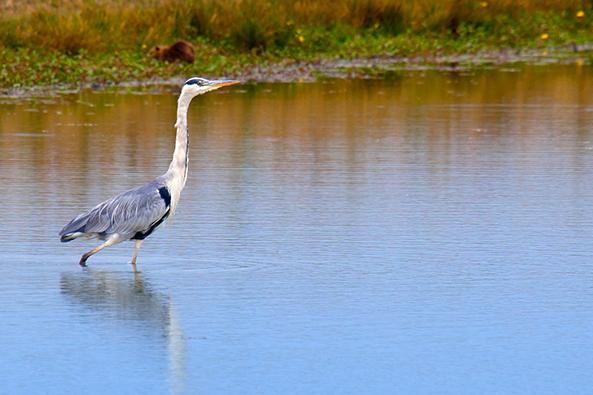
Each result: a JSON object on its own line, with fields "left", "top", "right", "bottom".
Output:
{"left": 0, "top": 0, "right": 590, "bottom": 53}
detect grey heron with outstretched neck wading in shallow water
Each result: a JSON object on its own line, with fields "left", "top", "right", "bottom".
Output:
{"left": 60, "top": 77, "right": 239, "bottom": 266}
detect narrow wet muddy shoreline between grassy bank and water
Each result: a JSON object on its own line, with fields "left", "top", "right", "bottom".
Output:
{"left": 0, "top": 44, "right": 593, "bottom": 98}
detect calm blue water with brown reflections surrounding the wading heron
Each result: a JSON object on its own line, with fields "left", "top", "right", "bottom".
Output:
{"left": 0, "top": 66, "right": 593, "bottom": 394}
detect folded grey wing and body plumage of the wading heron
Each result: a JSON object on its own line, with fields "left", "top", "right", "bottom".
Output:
{"left": 60, "top": 182, "right": 171, "bottom": 238}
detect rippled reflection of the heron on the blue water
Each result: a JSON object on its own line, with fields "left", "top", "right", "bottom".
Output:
{"left": 60, "top": 270, "right": 185, "bottom": 393}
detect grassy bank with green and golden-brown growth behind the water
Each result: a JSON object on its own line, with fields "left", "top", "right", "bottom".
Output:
{"left": 0, "top": 0, "right": 593, "bottom": 88}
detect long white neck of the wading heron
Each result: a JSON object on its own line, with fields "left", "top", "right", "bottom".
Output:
{"left": 165, "top": 93, "right": 193, "bottom": 214}
